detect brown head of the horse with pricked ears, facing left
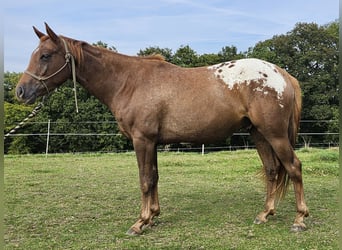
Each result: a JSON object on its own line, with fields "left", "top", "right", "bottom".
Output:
{"left": 16, "top": 23, "right": 73, "bottom": 104}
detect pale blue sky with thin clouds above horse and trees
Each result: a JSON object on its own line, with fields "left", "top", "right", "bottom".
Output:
{"left": 2, "top": 0, "right": 339, "bottom": 72}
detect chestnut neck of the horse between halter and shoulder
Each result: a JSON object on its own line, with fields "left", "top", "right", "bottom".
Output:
{"left": 77, "top": 45, "right": 129, "bottom": 111}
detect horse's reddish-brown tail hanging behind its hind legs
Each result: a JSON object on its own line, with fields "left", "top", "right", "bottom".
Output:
{"left": 274, "top": 74, "right": 302, "bottom": 199}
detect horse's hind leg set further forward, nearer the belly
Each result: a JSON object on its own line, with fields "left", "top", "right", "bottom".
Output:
{"left": 251, "top": 128, "right": 280, "bottom": 224}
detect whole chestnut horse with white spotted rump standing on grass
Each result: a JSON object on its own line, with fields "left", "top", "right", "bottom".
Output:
{"left": 15, "top": 23, "right": 309, "bottom": 235}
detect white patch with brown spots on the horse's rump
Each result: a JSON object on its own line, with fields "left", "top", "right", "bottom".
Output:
{"left": 208, "top": 58, "right": 286, "bottom": 99}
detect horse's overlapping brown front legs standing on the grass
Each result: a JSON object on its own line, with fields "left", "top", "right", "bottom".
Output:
{"left": 127, "top": 138, "right": 160, "bottom": 235}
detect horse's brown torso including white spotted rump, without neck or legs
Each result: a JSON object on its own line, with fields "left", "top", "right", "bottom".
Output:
{"left": 122, "top": 59, "right": 294, "bottom": 143}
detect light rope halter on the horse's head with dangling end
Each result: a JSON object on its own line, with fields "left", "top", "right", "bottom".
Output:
{"left": 24, "top": 38, "right": 78, "bottom": 113}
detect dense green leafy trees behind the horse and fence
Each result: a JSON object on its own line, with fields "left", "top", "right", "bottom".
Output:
{"left": 4, "top": 21, "right": 339, "bottom": 154}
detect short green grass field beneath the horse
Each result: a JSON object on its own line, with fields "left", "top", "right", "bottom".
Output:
{"left": 5, "top": 149, "right": 339, "bottom": 250}
